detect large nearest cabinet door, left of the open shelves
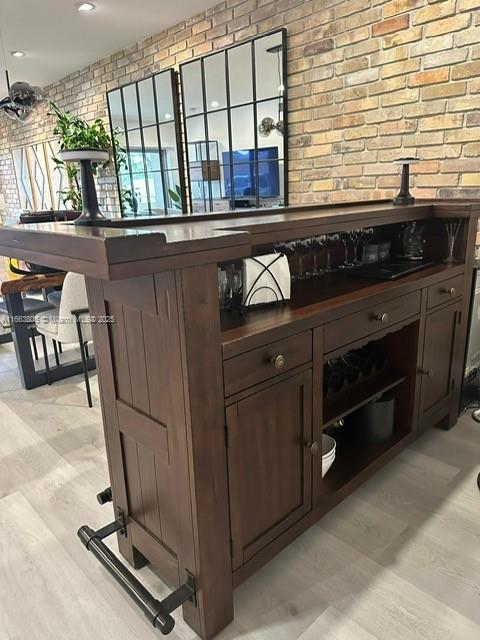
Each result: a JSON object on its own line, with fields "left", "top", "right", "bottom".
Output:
{"left": 227, "top": 371, "right": 312, "bottom": 569}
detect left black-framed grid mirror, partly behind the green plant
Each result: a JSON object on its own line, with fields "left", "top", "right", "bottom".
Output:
{"left": 107, "top": 69, "right": 186, "bottom": 216}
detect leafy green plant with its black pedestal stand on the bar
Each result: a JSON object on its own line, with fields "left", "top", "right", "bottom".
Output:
{"left": 49, "top": 102, "right": 118, "bottom": 225}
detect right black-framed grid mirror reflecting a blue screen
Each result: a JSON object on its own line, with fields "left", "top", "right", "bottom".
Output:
{"left": 180, "top": 29, "right": 288, "bottom": 213}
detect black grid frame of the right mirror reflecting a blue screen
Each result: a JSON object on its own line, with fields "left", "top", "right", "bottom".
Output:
{"left": 179, "top": 27, "right": 289, "bottom": 215}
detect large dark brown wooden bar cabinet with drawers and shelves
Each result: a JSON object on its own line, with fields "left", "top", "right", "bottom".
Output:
{"left": 0, "top": 200, "right": 480, "bottom": 639}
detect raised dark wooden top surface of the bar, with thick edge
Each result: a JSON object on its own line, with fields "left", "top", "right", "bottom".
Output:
{"left": 0, "top": 200, "right": 480, "bottom": 279}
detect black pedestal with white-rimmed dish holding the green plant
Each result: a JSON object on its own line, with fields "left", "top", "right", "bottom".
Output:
{"left": 59, "top": 149, "right": 109, "bottom": 225}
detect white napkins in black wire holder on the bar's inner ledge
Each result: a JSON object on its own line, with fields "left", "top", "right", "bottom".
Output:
{"left": 242, "top": 253, "right": 290, "bottom": 307}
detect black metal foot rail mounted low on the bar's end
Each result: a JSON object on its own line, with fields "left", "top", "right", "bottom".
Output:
{"left": 78, "top": 510, "right": 196, "bottom": 636}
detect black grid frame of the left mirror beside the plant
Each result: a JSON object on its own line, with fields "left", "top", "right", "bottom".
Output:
{"left": 107, "top": 69, "right": 187, "bottom": 218}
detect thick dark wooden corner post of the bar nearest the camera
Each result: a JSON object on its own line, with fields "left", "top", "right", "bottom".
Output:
{"left": 177, "top": 265, "right": 233, "bottom": 638}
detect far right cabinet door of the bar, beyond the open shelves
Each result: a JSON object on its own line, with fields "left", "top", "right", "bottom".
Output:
{"left": 422, "top": 304, "right": 460, "bottom": 412}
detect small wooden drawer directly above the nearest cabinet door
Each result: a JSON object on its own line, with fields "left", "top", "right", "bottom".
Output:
{"left": 223, "top": 331, "right": 312, "bottom": 396}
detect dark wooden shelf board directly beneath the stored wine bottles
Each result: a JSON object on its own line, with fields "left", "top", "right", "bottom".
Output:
{"left": 323, "top": 369, "right": 406, "bottom": 428}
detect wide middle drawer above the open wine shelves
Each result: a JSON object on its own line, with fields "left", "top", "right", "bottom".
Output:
{"left": 324, "top": 291, "right": 421, "bottom": 352}
